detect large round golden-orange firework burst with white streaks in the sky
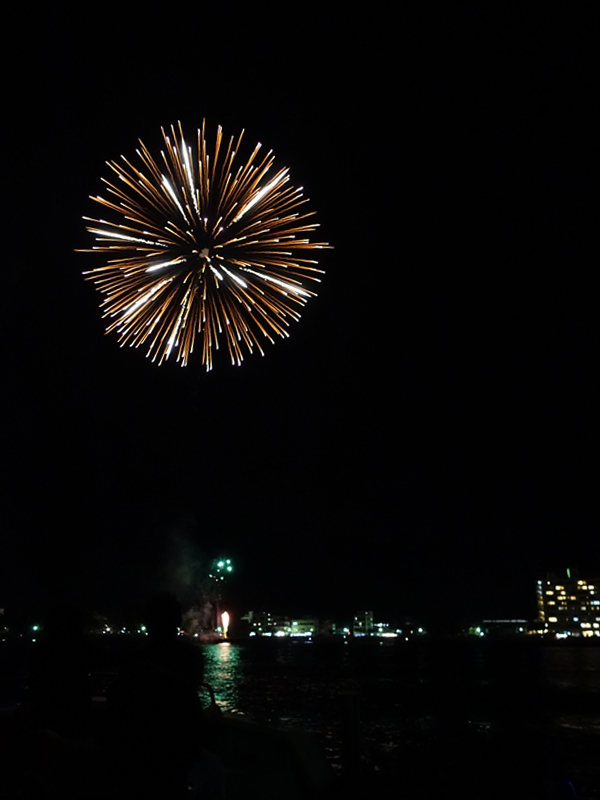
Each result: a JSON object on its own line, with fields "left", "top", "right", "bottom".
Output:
{"left": 79, "top": 122, "right": 329, "bottom": 369}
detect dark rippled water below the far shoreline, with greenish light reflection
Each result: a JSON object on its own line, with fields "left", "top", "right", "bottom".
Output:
{"left": 0, "top": 637, "right": 600, "bottom": 800}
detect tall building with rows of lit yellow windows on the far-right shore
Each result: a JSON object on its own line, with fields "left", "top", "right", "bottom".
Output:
{"left": 537, "top": 570, "right": 600, "bottom": 638}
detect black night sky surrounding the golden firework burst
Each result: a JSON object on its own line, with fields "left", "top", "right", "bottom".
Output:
{"left": 0, "top": 3, "right": 600, "bottom": 632}
